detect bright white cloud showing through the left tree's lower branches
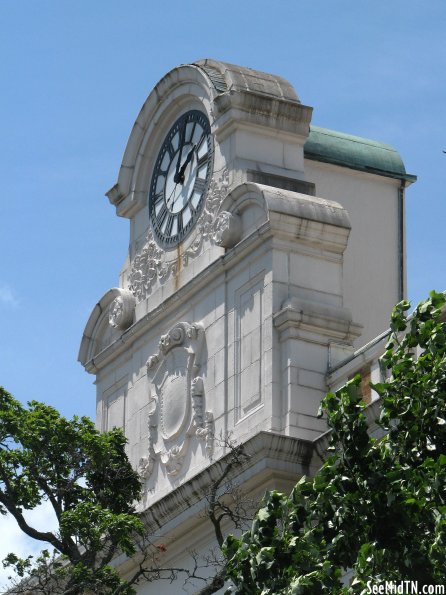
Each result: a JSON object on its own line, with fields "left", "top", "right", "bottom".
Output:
{"left": 0, "top": 502, "right": 57, "bottom": 592}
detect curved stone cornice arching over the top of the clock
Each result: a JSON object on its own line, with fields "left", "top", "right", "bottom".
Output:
{"left": 107, "top": 59, "right": 311, "bottom": 217}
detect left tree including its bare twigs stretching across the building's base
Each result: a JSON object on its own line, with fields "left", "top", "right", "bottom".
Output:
{"left": 0, "top": 387, "right": 255, "bottom": 595}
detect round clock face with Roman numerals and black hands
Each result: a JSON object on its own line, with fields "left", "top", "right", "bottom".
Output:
{"left": 149, "top": 110, "right": 214, "bottom": 248}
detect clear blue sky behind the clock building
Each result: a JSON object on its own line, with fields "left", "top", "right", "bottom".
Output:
{"left": 0, "top": 0, "right": 446, "bottom": 426}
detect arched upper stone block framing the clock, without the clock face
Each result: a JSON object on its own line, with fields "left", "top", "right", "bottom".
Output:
{"left": 101, "top": 59, "right": 312, "bottom": 319}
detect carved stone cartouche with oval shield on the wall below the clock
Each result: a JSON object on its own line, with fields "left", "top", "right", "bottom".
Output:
{"left": 140, "top": 322, "right": 214, "bottom": 478}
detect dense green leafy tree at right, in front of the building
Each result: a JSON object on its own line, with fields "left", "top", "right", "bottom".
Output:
{"left": 224, "top": 292, "right": 446, "bottom": 595}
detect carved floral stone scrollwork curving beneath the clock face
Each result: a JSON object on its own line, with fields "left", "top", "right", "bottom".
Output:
{"left": 129, "top": 169, "right": 229, "bottom": 302}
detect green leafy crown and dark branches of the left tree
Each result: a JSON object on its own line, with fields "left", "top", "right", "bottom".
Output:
{"left": 0, "top": 388, "right": 143, "bottom": 595}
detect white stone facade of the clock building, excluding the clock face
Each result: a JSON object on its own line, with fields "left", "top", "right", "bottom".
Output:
{"left": 79, "top": 60, "right": 414, "bottom": 593}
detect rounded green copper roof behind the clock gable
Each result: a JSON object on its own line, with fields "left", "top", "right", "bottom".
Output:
{"left": 304, "top": 126, "right": 417, "bottom": 182}
